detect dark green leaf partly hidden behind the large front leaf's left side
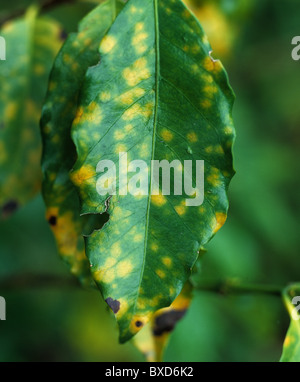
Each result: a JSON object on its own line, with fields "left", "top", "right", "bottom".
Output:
{"left": 41, "top": 0, "right": 122, "bottom": 285}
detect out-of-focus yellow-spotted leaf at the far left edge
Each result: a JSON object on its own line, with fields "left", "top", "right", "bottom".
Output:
{"left": 0, "top": 8, "right": 62, "bottom": 218}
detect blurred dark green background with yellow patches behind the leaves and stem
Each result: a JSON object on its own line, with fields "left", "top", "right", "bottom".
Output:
{"left": 0, "top": 0, "right": 300, "bottom": 362}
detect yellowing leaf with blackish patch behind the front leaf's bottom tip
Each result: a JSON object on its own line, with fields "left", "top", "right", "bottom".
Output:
{"left": 133, "top": 282, "right": 193, "bottom": 362}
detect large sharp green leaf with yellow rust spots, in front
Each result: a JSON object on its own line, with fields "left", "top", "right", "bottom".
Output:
{"left": 72, "top": 0, "right": 234, "bottom": 342}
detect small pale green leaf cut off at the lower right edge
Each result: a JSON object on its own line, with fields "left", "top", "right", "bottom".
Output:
{"left": 280, "top": 284, "right": 300, "bottom": 362}
